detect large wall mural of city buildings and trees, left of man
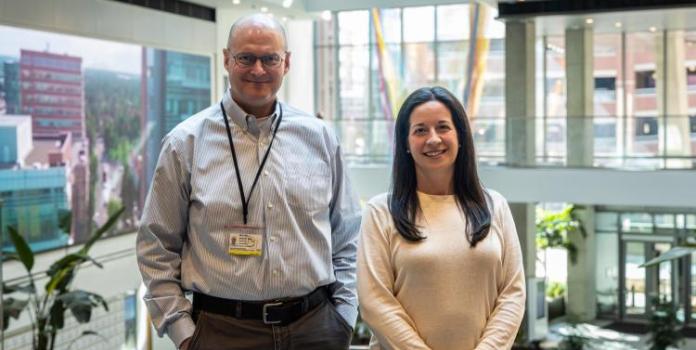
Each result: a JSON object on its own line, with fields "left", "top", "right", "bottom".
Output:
{"left": 0, "top": 26, "right": 211, "bottom": 251}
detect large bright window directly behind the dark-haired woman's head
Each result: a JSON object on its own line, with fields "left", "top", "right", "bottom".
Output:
{"left": 315, "top": 4, "right": 505, "bottom": 162}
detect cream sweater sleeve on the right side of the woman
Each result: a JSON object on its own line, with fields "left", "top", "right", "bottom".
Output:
{"left": 476, "top": 199, "right": 526, "bottom": 350}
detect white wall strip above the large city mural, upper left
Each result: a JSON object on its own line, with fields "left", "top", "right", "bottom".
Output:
{"left": 0, "top": 0, "right": 216, "bottom": 55}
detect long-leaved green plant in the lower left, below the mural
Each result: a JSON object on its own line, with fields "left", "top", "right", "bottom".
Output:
{"left": 2, "top": 208, "right": 123, "bottom": 350}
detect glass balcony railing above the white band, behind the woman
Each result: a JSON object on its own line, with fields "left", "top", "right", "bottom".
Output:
{"left": 330, "top": 115, "right": 696, "bottom": 169}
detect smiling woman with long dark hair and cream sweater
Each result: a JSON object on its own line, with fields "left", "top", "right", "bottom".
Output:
{"left": 358, "top": 87, "right": 525, "bottom": 350}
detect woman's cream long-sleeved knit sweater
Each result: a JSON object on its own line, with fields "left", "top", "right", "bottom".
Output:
{"left": 358, "top": 191, "right": 525, "bottom": 350}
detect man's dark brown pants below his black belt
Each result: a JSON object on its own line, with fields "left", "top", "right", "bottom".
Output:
{"left": 189, "top": 300, "right": 353, "bottom": 350}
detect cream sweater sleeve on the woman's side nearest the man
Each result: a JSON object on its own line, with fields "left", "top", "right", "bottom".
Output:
{"left": 358, "top": 204, "right": 430, "bottom": 350}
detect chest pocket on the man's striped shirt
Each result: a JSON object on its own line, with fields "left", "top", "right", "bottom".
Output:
{"left": 285, "top": 159, "right": 332, "bottom": 212}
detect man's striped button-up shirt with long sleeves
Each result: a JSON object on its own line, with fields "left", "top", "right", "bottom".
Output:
{"left": 137, "top": 92, "right": 360, "bottom": 346}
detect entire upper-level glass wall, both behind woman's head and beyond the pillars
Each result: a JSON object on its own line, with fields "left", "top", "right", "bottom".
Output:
{"left": 315, "top": 9, "right": 696, "bottom": 169}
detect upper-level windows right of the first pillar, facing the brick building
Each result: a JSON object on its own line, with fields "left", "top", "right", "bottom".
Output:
{"left": 536, "top": 31, "right": 696, "bottom": 169}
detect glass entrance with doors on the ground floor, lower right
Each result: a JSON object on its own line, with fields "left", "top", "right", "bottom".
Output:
{"left": 595, "top": 207, "right": 696, "bottom": 325}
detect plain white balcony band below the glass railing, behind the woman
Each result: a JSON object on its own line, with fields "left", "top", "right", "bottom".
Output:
{"left": 349, "top": 165, "right": 696, "bottom": 209}
